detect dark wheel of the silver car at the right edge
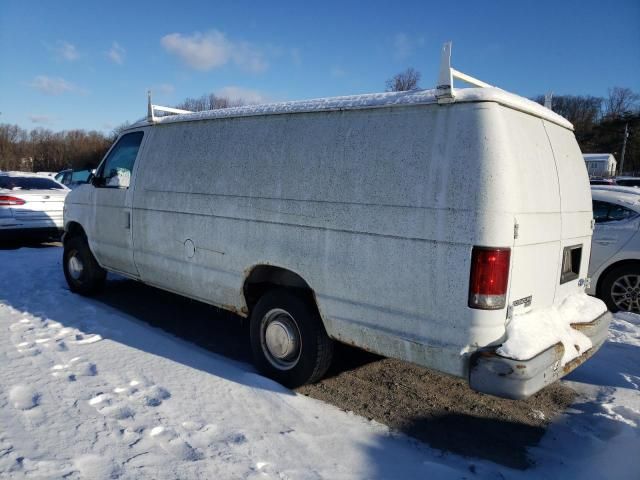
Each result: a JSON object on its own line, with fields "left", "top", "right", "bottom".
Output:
{"left": 598, "top": 263, "right": 640, "bottom": 313}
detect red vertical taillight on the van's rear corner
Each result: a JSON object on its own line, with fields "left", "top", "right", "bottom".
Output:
{"left": 469, "top": 247, "right": 511, "bottom": 310}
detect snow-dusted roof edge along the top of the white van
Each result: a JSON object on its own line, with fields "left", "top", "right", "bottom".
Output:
{"left": 127, "top": 87, "right": 573, "bottom": 130}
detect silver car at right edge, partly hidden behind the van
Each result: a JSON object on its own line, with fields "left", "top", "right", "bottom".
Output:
{"left": 587, "top": 187, "right": 640, "bottom": 313}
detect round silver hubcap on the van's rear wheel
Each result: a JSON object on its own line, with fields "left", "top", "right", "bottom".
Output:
{"left": 262, "top": 308, "right": 302, "bottom": 370}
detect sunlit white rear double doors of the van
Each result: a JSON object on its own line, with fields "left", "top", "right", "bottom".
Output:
{"left": 500, "top": 107, "right": 592, "bottom": 313}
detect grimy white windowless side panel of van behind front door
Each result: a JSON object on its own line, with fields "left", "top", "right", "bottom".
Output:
{"left": 134, "top": 104, "right": 513, "bottom": 374}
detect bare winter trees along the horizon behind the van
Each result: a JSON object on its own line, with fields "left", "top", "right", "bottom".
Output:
{"left": 0, "top": 77, "right": 640, "bottom": 174}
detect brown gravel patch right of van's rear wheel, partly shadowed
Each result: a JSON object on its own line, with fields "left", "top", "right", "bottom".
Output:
{"left": 297, "top": 346, "right": 576, "bottom": 469}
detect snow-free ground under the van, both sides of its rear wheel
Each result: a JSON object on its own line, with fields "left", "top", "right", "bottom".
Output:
{"left": 92, "top": 274, "right": 575, "bottom": 469}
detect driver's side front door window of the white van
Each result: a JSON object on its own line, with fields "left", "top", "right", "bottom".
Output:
{"left": 96, "top": 132, "right": 144, "bottom": 188}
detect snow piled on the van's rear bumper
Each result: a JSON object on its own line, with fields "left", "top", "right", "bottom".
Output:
{"left": 497, "top": 293, "right": 607, "bottom": 365}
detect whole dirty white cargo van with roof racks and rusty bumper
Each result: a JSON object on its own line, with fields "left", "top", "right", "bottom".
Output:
{"left": 63, "top": 45, "right": 610, "bottom": 398}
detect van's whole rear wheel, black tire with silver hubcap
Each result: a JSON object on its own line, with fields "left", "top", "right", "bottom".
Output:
{"left": 250, "top": 289, "right": 333, "bottom": 388}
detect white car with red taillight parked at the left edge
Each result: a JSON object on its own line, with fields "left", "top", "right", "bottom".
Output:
{"left": 0, "top": 172, "right": 69, "bottom": 240}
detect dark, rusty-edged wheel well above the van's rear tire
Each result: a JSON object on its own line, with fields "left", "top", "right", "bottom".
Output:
{"left": 243, "top": 265, "right": 316, "bottom": 311}
